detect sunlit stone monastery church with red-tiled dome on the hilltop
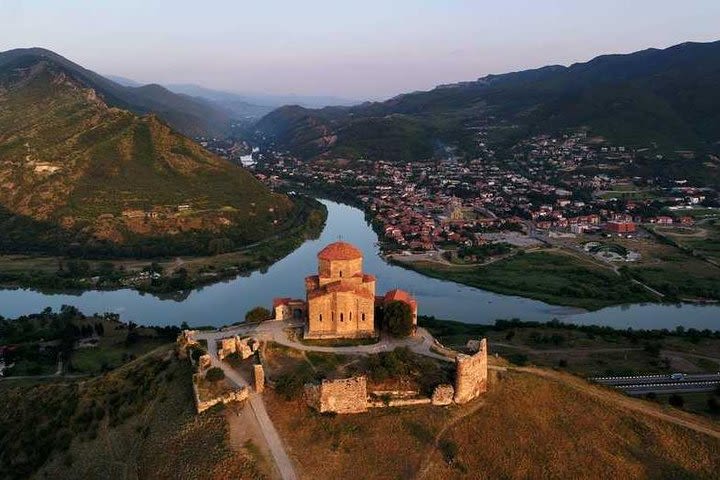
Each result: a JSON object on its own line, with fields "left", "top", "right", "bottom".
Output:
{"left": 273, "top": 242, "right": 417, "bottom": 338}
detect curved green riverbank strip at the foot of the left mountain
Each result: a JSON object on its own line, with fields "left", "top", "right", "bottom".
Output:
{"left": 0, "top": 196, "right": 327, "bottom": 294}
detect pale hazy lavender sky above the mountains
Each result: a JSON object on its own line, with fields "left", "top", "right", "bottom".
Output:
{"left": 0, "top": 0, "right": 720, "bottom": 99}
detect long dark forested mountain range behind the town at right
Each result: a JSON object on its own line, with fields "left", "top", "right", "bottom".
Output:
{"left": 256, "top": 42, "right": 720, "bottom": 165}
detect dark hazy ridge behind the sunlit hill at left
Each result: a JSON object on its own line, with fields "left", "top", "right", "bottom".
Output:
{"left": 0, "top": 48, "right": 231, "bottom": 136}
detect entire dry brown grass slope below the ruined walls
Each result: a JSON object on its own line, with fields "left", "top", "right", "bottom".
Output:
{"left": 266, "top": 364, "right": 720, "bottom": 479}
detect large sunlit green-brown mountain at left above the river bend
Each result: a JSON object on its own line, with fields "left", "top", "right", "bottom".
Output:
{"left": 0, "top": 53, "right": 293, "bottom": 255}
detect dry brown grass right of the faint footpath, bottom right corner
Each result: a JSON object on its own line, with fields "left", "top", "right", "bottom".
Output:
{"left": 426, "top": 373, "right": 720, "bottom": 479}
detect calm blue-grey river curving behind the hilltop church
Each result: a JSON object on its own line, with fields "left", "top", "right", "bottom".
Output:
{"left": 0, "top": 200, "right": 720, "bottom": 330}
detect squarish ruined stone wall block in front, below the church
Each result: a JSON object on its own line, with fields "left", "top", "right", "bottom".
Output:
{"left": 305, "top": 377, "right": 368, "bottom": 413}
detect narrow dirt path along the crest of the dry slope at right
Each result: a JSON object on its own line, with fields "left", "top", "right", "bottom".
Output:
{"left": 510, "top": 367, "right": 720, "bottom": 439}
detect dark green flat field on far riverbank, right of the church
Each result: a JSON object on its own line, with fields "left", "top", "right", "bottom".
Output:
{"left": 402, "top": 250, "right": 656, "bottom": 310}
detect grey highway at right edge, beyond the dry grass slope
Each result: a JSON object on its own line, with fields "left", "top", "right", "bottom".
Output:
{"left": 590, "top": 373, "right": 720, "bottom": 395}
